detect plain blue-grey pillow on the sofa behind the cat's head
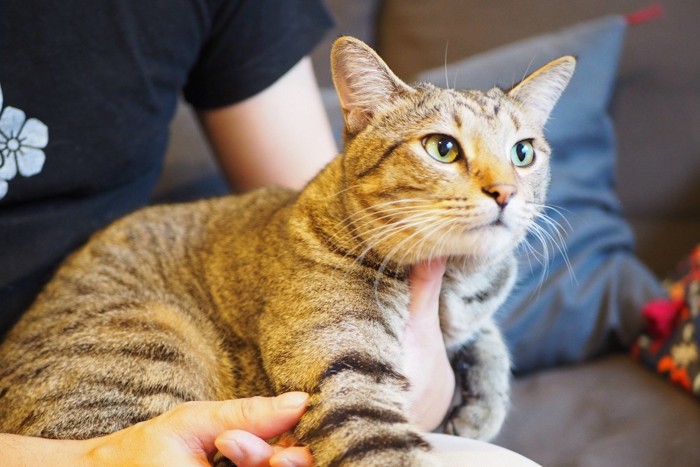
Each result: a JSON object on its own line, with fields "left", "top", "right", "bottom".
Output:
{"left": 419, "top": 16, "right": 664, "bottom": 372}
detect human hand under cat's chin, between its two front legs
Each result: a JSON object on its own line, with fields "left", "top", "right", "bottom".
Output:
{"left": 404, "top": 258, "right": 455, "bottom": 431}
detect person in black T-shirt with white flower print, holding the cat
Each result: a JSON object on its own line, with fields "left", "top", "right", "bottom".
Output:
{"left": 0, "top": 0, "right": 455, "bottom": 465}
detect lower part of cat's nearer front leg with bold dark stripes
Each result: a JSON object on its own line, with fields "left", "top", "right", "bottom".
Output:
{"left": 296, "top": 350, "right": 439, "bottom": 466}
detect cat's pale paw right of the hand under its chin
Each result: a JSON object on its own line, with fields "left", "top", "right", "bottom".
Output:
{"left": 447, "top": 396, "right": 508, "bottom": 441}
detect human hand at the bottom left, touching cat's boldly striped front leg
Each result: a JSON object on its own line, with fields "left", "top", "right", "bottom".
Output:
{"left": 86, "top": 392, "right": 313, "bottom": 467}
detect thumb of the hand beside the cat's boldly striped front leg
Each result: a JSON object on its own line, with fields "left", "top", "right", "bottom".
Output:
{"left": 164, "top": 392, "right": 309, "bottom": 452}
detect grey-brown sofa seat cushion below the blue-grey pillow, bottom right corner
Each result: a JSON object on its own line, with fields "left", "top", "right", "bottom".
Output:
{"left": 494, "top": 355, "right": 700, "bottom": 467}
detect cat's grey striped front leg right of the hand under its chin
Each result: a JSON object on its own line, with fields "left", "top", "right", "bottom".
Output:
{"left": 445, "top": 321, "right": 510, "bottom": 441}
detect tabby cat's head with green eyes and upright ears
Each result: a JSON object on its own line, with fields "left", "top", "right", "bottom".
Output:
{"left": 331, "top": 37, "right": 575, "bottom": 264}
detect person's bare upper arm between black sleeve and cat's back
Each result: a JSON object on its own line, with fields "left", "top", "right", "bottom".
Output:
{"left": 199, "top": 58, "right": 337, "bottom": 191}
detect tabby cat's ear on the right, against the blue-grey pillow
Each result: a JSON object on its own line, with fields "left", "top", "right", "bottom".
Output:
{"left": 508, "top": 55, "right": 576, "bottom": 126}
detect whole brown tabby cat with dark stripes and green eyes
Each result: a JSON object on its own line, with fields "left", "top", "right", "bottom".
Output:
{"left": 0, "top": 37, "right": 575, "bottom": 466}
